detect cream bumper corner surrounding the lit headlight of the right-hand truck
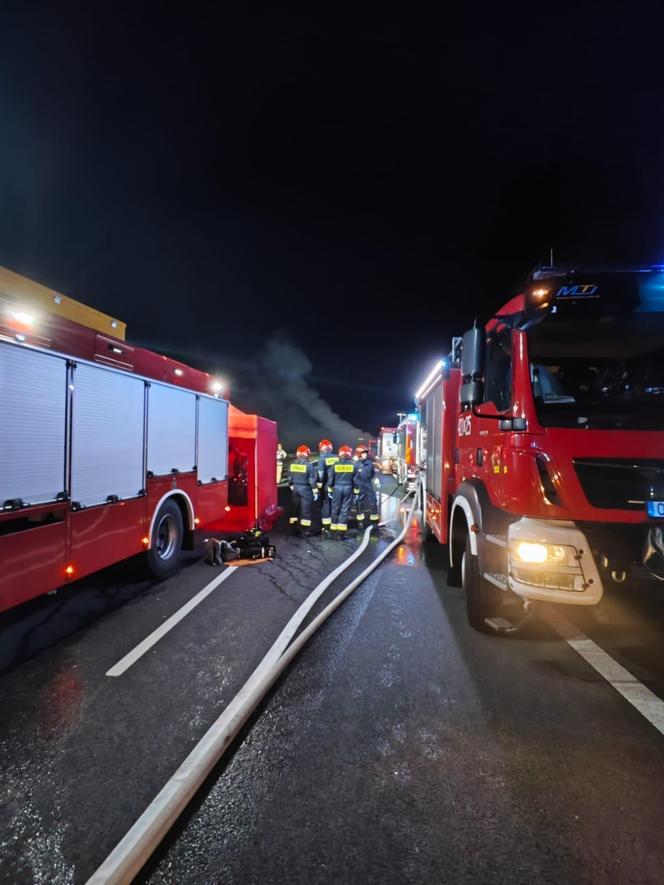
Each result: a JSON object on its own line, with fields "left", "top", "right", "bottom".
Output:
{"left": 507, "top": 517, "right": 604, "bottom": 605}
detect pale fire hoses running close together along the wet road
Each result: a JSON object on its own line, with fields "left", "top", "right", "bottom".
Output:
{"left": 88, "top": 491, "right": 419, "bottom": 885}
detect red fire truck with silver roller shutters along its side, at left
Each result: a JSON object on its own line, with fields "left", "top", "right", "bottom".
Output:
{"left": 0, "top": 268, "right": 278, "bottom": 611}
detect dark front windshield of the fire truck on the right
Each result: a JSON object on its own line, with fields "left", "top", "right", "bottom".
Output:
{"left": 528, "top": 315, "right": 664, "bottom": 430}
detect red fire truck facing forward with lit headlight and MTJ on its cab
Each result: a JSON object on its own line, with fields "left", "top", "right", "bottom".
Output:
{"left": 416, "top": 267, "right": 664, "bottom": 632}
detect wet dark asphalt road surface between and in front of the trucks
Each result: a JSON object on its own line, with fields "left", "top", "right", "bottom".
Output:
{"left": 0, "top": 476, "right": 664, "bottom": 885}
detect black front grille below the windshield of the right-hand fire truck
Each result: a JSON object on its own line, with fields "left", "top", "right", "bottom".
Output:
{"left": 574, "top": 458, "right": 664, "bottom": 510}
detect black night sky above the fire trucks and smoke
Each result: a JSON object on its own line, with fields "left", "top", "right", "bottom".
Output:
{"left": 0, "top": 2, "right": 664, "bottom": 430}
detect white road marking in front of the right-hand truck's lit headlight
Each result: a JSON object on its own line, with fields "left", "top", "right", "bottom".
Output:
{"left": 545, "top": 610, "right": 664, "bottom": 734}
